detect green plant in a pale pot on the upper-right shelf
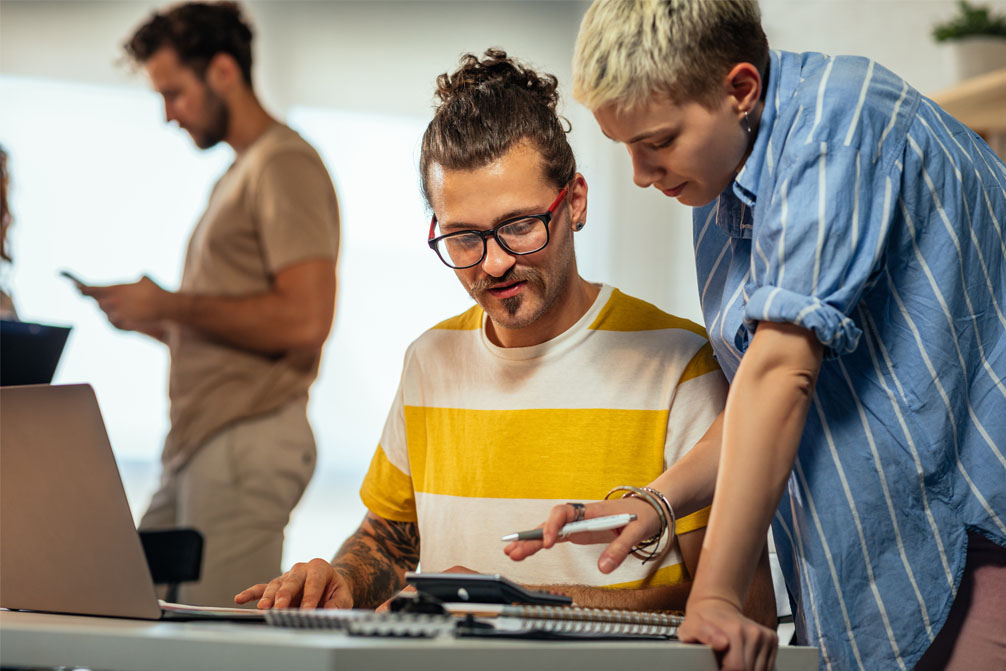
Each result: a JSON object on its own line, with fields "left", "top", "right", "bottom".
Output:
{"left": 933, "top": 0, "right": 1006, "bottom": 79}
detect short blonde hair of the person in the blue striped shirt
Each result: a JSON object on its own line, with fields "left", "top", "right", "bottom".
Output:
{"left": 572, "top": 0, "right": 769, "bottom": 110}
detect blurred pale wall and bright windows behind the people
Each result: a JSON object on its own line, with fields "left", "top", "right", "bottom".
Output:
{"left": 0, "top": 0, "right": 993, "bottom": 568}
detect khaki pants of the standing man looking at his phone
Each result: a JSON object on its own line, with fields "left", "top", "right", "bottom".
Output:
{"left": 140, "top": 400, "right": 316, "bottom": 607}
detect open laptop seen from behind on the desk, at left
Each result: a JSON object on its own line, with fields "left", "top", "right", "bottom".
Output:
{"left": 0, "top": 384, "right": 263, "bottom": 620}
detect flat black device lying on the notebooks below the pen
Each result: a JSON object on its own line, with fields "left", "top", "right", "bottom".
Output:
{"left": 405, "top": 571, "right": 572, "bottom": 606}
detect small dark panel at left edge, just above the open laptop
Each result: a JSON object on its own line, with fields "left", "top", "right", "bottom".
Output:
{"left": 0, "top": 319, "right": 69, "bottom": 386}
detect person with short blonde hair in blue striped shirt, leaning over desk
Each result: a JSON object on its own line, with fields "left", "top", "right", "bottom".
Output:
{"left": 507, "top": 0, "right": 1006, "bottom": 669}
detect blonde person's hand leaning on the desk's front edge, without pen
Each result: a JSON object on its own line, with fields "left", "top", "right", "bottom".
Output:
{"left": 678, "top": 598, "right": 779, "bottom": 671}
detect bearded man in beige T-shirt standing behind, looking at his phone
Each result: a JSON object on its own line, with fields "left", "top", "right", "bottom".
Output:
{"left": 80, "top": 2, "right": 339, "bottom": 606}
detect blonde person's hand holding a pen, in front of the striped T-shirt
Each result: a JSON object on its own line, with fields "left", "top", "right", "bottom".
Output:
{"left": 503, "top": 498, "right": 660, "bottom": 573}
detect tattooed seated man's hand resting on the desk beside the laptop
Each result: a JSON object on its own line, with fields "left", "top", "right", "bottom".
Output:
{"left": 234, "top": 558, "right": 353, "bottom": 610}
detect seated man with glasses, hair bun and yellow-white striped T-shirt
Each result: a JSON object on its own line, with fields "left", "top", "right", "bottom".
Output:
{"left": 235, "top": 50, "right": 775, "bottom": 624}
